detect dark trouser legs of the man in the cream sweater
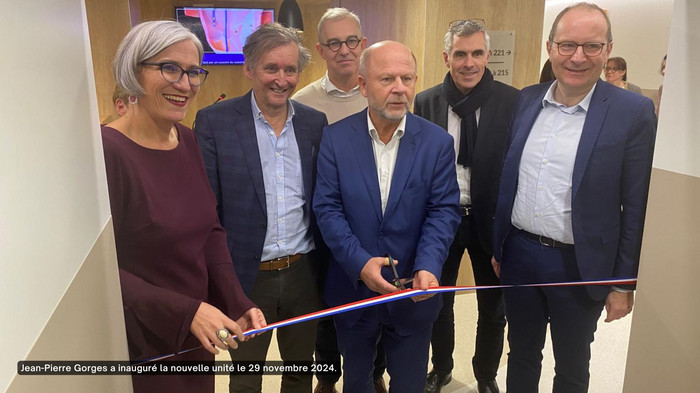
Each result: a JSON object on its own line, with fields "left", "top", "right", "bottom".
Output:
{"left": 316, "top": 316, "right": 386, "bottom": 385}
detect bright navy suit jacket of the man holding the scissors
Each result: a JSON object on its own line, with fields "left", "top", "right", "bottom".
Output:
{"left": 314, "top": 109, "right": 461, "bottom": 330}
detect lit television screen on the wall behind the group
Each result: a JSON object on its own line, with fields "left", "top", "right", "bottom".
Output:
{"left": 175, "top": 7, "right": 275, "bottom": 65}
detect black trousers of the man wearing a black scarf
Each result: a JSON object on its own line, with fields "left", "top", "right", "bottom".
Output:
{"left": 430, "top": 216, "right": 506, "bottom": 381}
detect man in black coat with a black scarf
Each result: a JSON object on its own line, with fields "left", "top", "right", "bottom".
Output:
{"left": 414, "top": 20, "right": 518, "bottom": 393}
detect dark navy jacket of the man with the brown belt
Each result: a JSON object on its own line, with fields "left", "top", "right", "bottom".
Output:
{"left": 195, "top": 91, "right": 328, "bottom": 294}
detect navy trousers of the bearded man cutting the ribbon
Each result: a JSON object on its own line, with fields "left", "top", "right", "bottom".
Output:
{"left": 336, "top": 304, "right": 432, "bottom": 393}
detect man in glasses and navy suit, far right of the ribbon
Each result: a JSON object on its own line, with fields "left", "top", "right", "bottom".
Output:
{"left": 493, "top": 3, "right": 656, "bottom": 393}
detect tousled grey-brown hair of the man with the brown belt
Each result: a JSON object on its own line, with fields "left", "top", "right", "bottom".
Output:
{"left": 243, "top": 22, "right": 311, "bottom": 72}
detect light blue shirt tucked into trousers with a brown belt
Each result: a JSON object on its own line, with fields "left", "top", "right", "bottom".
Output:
{"left": 250, "top": 94, "right": 314, "bottom": 261}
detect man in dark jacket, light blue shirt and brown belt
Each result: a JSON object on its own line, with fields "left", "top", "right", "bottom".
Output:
{"left": 195, "top": 23, "right": 328, "bottom": 393}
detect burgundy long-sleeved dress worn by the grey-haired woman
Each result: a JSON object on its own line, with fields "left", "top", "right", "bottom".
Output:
{"left": 102, "top": 124, "right": 255, "bottom": 392}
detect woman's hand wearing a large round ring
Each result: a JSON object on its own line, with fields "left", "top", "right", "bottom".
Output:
{"left": 190, "top": 302, "right": 247, "bottom": 355}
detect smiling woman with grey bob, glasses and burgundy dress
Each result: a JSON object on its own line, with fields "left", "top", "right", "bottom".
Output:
{"left": 102, "top": 21, "right": 265, "bottom": 392}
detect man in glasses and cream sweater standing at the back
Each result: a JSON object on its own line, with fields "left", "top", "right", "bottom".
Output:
{"left": 292, "top": 8, "right": 386, "bottom": 393}
